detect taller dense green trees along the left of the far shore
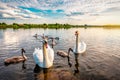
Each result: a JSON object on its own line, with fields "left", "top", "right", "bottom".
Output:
{"left": 0, "top": 22, "right": 72, "bottom": 29}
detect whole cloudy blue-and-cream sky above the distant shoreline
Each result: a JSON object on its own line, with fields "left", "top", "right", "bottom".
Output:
{"left": 0, "top": 0, "right": 120, "bottom": 25}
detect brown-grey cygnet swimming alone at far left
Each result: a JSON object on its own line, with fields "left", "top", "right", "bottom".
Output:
{"left": 4, "top": 48, "right": 27, "bottom": 65}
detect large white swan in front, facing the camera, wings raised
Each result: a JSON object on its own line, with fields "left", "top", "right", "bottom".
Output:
{"left": 33, "top": 39, "right": 54, "bottom": 68}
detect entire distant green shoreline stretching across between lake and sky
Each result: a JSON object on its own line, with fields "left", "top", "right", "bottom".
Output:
{"left": 0, "top": 22, "right": 120, "bottom": 29}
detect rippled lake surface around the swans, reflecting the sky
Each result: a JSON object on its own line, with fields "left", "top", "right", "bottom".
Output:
{"left": 0, "top": 28, "right": 120, "bottom": 80}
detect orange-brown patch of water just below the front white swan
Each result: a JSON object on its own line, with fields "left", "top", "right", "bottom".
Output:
{"left": 34, "top": 65, "right": 77, "bottom": 80}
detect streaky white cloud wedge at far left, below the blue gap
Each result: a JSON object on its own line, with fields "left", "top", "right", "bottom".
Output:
{"left": 0, "top": 2, "right": 42, "bottom": 19}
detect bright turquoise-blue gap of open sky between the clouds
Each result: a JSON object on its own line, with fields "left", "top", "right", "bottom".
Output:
{"left": 19, "top": 6, "right": 65, "bottom": 18}
